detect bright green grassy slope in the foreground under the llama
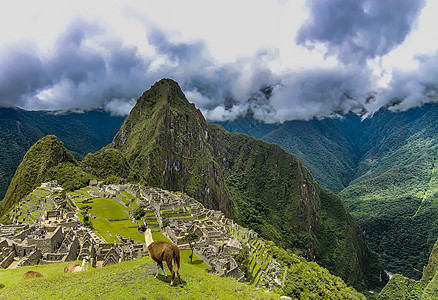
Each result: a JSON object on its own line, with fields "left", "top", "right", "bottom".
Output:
{"left": 0, "top": 257, "right": 280, "bottom": 299}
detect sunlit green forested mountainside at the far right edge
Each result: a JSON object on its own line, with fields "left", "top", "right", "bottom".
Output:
{"left": 340, "top": 105, "right": 438, "bottom": 279}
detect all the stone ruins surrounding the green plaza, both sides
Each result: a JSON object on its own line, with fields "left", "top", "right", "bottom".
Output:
{"left": 0, "top": 181, "right": 286, "bottom": 287}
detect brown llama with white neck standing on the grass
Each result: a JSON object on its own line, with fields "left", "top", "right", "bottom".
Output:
{"left": 138, "top": 223, "right": 183, "bottom": 287}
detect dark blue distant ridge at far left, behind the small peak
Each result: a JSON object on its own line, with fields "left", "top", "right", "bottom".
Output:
{"left": 0, "top": 106, "right": 125, "bottom": 199}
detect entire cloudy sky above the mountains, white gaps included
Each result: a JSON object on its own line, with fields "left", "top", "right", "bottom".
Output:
{"left": 0, "top": 0, "right": 438, "bottom": 122}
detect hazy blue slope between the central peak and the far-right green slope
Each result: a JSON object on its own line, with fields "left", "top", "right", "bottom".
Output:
{"left": 218, "top": 115, "right": 362, "bottom": 193}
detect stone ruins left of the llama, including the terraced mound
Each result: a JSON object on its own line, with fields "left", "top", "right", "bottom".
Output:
{"left": 0, "top": 181, "right": 148, "bottom": 269}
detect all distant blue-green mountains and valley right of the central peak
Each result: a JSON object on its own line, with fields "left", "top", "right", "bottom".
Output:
{"left": 221, "top": 103, "right": 438, "bottom": 279}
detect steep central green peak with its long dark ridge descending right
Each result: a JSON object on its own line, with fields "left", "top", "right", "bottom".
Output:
{"left": 3, "top": 79, "right": 384, "bottom": 290}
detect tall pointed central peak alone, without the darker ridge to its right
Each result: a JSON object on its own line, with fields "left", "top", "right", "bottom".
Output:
{"left": 109, "top": 79, "right": 222, "bottom": 212}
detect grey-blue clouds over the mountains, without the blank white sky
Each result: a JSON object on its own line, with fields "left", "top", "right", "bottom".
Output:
{"left": 0, "top": 0, "right": 438, "bottom": 123}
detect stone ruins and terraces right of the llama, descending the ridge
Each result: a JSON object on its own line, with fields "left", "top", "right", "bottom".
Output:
{"left": 130, "top": 185, "right": 286, "bottom": 288}
